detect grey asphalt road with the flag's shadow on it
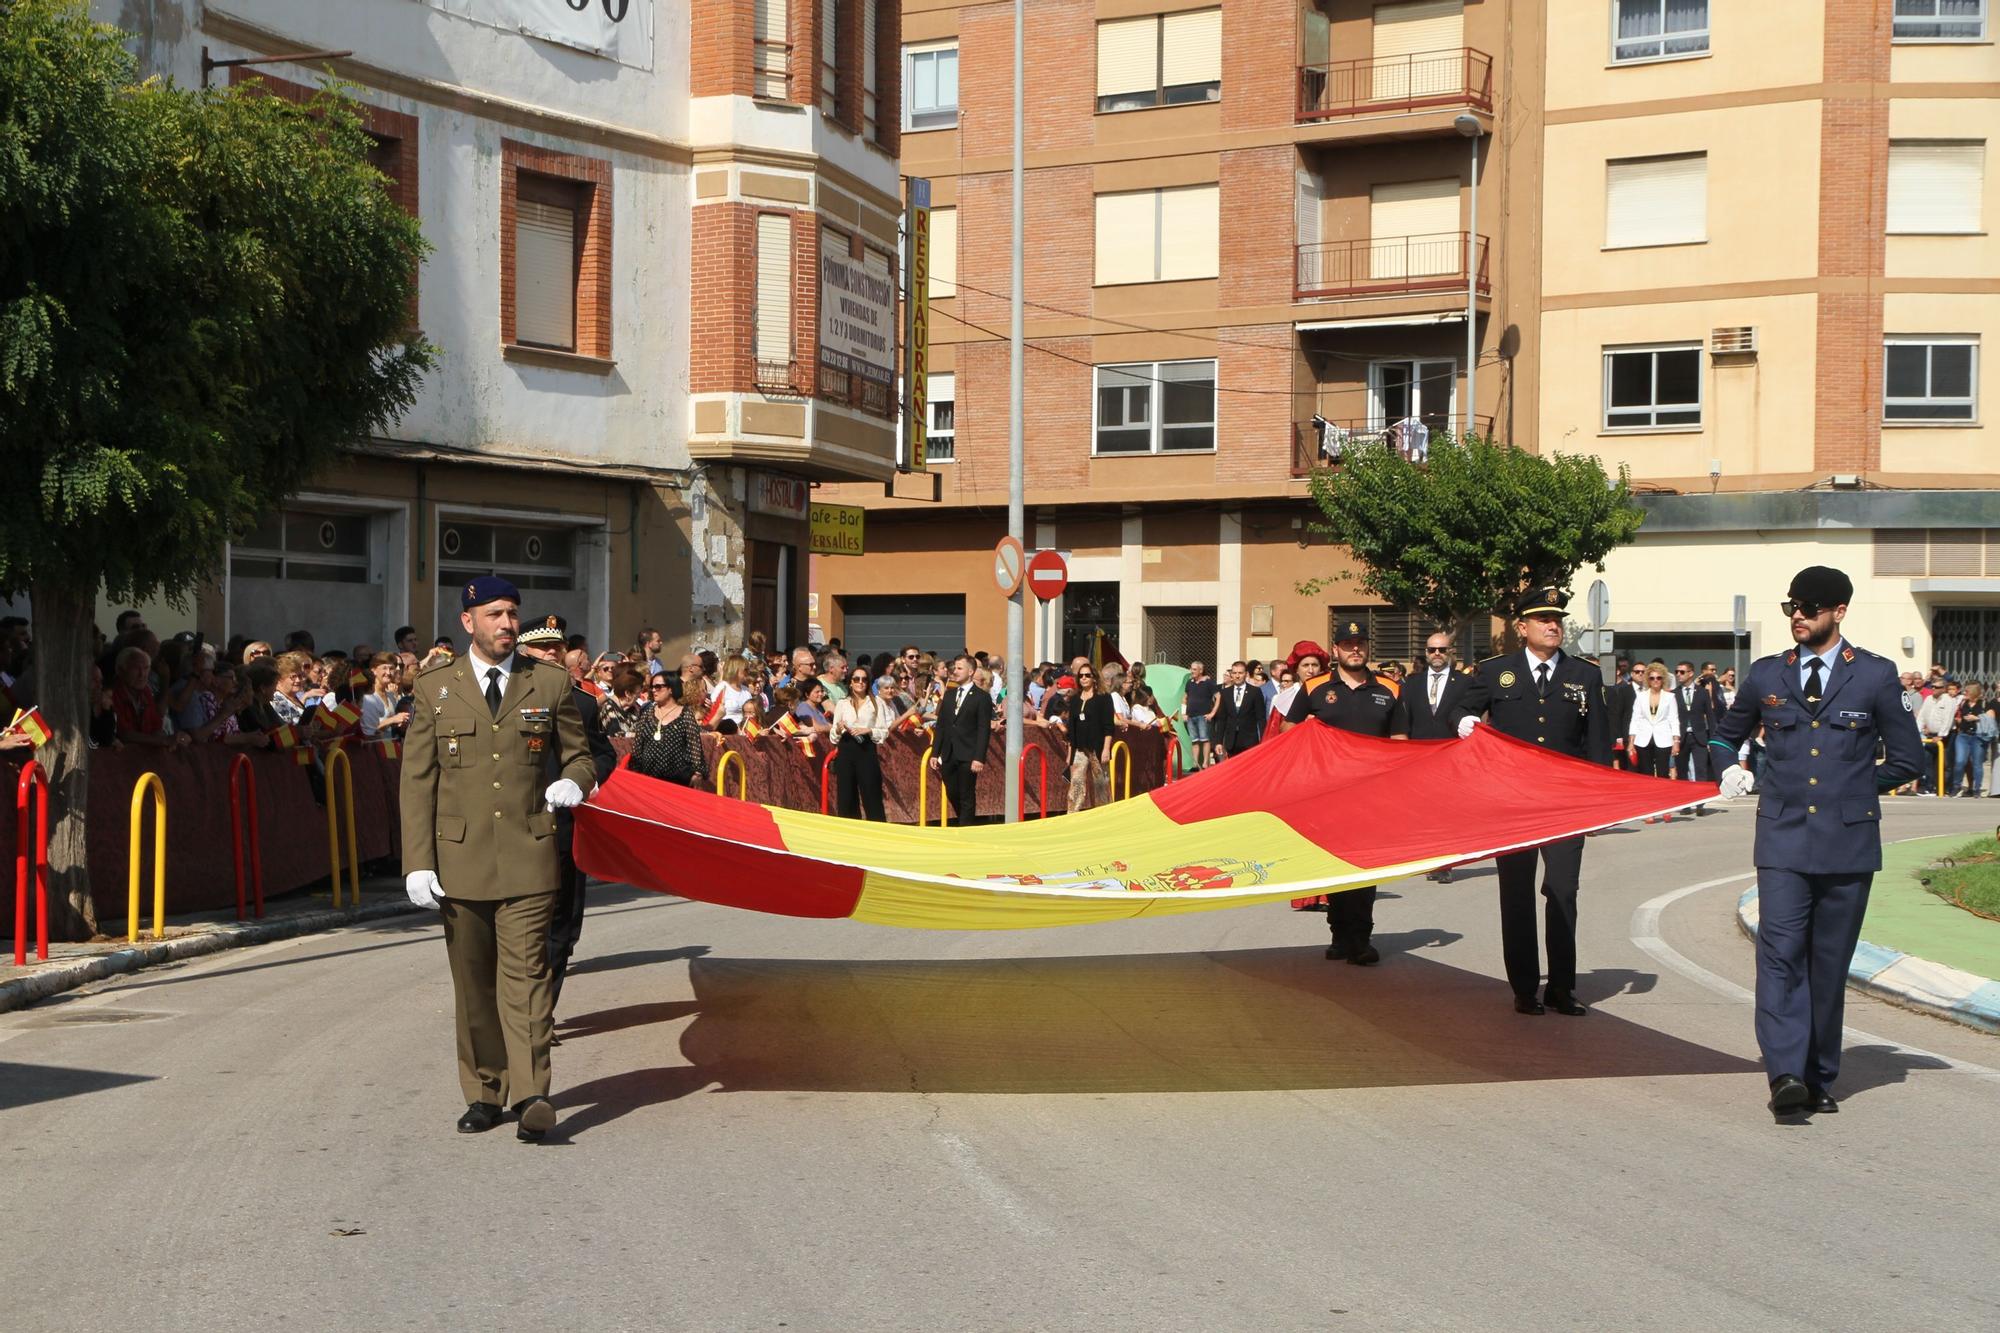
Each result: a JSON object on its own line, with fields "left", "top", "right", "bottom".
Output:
{"left": 0, "top": 801, "right": 2000, "bottom": 1333}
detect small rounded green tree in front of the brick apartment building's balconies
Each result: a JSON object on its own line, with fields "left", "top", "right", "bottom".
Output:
{"left": 1312, "top": 434, "right": 1646, "bottom": 626}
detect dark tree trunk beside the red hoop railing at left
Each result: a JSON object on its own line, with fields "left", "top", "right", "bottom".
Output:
{"left": 32, "top": 584, "right": 98, "bottom": 941}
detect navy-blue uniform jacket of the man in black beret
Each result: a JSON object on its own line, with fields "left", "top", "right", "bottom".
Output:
{"left": 1710, "top": 644, "right": 1924, "bottom": 875}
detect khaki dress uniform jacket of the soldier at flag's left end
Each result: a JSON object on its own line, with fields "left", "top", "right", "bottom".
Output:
{"left": 402, "top": 652, "right": 594, "bottom": 901}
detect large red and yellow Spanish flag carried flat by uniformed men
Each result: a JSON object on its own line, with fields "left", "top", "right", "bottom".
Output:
{"left": 576, "top": 723, "right": 1718, "bottom": 931}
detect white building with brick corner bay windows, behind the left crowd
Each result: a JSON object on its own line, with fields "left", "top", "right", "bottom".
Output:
{"left": 94, "top": 0, "right": 900, "bottom": 648}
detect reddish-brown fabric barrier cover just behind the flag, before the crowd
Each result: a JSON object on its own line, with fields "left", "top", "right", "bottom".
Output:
{"left": 612, "top": 725, "right": 1168, "bottom": 825}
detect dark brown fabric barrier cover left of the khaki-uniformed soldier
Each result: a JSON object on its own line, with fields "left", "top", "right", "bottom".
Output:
{"left": 0, "top": 745, "right": 402, "bottom": 924}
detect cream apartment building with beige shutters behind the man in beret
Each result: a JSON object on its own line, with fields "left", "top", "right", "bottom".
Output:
{"left": 1534, "top": 0, "right": 2000, "bottom": 679}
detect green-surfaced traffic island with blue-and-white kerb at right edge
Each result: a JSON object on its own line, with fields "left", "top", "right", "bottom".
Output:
{"left": 1736, "top": 833, "right": 2000, "bottom": 1033}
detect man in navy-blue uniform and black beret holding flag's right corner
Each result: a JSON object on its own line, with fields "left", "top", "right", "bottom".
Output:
{"left": 1710, "top": 564, "right": 1924, "bottom": 1123}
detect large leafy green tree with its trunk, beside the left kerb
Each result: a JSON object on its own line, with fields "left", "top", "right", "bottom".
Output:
{"left": 0, "top": 0, "right": 436, "bottom": 932}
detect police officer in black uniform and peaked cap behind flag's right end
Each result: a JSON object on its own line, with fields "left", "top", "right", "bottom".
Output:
{"left": 1458, "top": 588, "right": 1612, "bottom": 1017}
